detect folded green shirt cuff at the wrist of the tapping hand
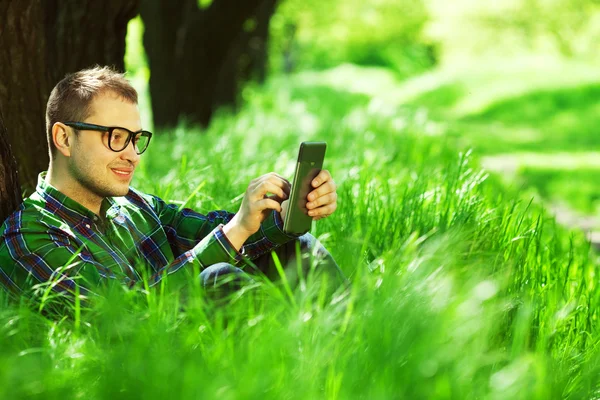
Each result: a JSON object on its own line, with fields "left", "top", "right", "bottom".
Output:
{"left": 193, "top": 224, "right": 243, "bottom": 269}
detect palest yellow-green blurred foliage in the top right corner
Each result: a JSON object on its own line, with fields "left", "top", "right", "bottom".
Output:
{"left": 429, "top": 0, "right": 600, "bottom": 62}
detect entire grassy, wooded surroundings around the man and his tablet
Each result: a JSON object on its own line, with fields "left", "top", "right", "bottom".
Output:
{"left": 0, "top": 0, "right": 600, "bottom": 400}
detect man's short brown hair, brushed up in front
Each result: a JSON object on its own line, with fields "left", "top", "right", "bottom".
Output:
{"left": 46, "top": 66, "right": 138, "bottom": 158}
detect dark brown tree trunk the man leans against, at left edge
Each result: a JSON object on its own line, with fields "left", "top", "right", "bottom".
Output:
{"left": 0, "top": 0, "right": 139, "bottom": 188}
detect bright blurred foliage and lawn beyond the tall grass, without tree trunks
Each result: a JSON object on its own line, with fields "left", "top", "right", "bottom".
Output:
{"left": 125, "top": 0, "right": 600, "bottom": 241}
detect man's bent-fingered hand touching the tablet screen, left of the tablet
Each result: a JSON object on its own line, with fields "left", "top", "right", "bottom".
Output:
{"left": 223, "top": 172, "right": 290, "bottom": 250}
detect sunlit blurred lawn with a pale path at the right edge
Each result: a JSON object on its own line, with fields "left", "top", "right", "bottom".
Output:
{"left": 398, "top": 61, "right": 600, "bottom": 217}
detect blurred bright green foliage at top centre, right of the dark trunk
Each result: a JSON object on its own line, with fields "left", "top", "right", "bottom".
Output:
{"left": 270, "top": 0, "right": 435, "bottom": 77}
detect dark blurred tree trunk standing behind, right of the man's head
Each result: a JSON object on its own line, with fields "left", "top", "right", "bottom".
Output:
{"left": 140, "top": 0, "right": 277, "bottom": 127}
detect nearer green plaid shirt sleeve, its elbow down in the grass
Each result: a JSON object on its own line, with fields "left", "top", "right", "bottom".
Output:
{"left": 0, "top": 217, "right": 227, "bottom": 301}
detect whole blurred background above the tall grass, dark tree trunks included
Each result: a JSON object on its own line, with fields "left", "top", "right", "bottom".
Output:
{"left": 0, "top": 0, "right": 600, "bottom": 236}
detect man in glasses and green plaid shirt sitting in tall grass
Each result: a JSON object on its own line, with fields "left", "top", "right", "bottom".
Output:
{"left": 0, "top": 67, "right": 344, "bottom": 304}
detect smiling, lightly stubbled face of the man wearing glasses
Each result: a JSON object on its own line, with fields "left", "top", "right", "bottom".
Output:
{"left": 68, "top": 92, "right": 141, "bottom": 202}
